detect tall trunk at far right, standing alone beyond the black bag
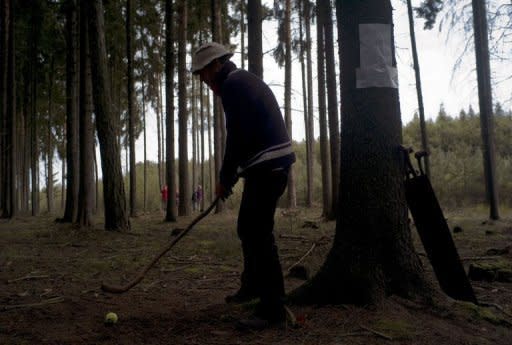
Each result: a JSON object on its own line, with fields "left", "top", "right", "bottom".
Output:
{"left": 472, "top": 0, "right": 500, "bottom": 220}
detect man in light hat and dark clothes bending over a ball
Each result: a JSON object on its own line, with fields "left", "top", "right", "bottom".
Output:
{"left": 192, "top": 42, "right": 295, "bottom": 329}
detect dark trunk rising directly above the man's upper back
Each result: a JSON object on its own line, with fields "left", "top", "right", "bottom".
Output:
{"left": 247, "top": 0, "right": 263, "bottom": 79}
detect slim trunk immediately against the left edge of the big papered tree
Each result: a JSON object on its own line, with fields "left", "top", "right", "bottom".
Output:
{"left": 319, "top": 0, "right": 340, "bottom": 219}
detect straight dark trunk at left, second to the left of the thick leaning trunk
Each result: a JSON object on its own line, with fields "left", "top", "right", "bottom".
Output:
{"left": 61, "top": 0, "right": 79, "bottom": 222}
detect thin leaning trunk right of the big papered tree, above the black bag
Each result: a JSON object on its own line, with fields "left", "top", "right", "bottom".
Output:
{"left": 407, "top": 0, "right": 430, "bottom": 178}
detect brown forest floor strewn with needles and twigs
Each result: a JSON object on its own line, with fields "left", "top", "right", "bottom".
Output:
{"left": 0, "top": 203, "right": 512, "bottom": 345}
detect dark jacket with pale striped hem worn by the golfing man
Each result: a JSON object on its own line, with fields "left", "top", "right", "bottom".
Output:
{"left": 216, "top": 61, "right": 295, "bottom": 189}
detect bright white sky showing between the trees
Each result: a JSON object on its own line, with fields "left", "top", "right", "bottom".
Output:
{"left": 132, "top": 0, "right": 512, "bottom": 166}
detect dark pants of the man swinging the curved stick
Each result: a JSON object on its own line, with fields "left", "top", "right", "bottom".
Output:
{"left": 238, "top": 170, "right": 288, "bottom": 318}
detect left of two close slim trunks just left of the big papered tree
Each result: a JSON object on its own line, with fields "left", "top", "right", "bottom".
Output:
{"left": 316, "top": 0, "right": 332, "bottom": 218}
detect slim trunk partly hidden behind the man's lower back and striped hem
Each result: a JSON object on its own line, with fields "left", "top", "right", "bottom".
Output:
{"left": 284, "top": 0, "right": 297, "bottom": 208}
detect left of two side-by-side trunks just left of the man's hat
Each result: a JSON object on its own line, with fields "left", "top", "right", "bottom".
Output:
{"left": 165, "top": 0, "right": 176, "bottom": 222}
